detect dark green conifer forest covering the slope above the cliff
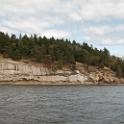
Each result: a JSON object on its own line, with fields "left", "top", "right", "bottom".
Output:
{"left": 0, "top": 32, "right": 124, "bottom": 77}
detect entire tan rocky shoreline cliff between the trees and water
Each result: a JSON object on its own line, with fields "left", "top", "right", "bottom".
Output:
{"left": 0, "top": 58, "right": 124, "bottom": 85}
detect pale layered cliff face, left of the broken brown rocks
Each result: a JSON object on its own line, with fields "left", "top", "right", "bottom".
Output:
{"left": 0, "top": 59, "right": 89, "bottom": 85}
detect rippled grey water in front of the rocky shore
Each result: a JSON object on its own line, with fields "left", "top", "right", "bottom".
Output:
{"left": 0, "top": 86, "right": 124, "bottom": 124}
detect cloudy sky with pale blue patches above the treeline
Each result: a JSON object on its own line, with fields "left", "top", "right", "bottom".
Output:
{"left": 0, "top": 0, "right": 124, "bottom": 56}
